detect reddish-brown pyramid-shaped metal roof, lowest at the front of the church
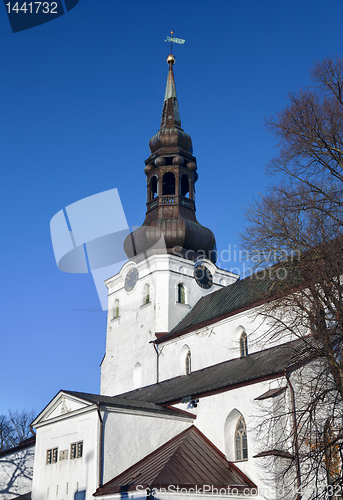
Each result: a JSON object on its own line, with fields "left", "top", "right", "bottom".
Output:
{"left": 94, "top": 426, "right": 256, "bottom": 496}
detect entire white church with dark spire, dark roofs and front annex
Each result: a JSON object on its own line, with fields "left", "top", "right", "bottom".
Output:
{"left": 0, "top": 56, "right": 334, "bottom": 500}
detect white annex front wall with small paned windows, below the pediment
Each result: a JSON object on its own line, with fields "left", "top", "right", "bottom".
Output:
{"left": 32, "top": 410, "right": 99, "bottom": 500}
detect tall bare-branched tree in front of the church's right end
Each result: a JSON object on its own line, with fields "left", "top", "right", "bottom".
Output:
{"left": 241, "top": 58, "right": 343, "bottom": 498}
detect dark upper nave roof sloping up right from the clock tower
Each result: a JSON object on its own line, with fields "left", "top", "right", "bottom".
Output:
{"left": 159, "top": 262, "right": 300, "bottom": 344}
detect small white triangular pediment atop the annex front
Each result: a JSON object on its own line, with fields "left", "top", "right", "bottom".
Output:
{"left": 32, "top": 391, "right": 93, "bottom": 427}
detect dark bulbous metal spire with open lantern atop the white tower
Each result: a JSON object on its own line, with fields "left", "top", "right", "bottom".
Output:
{"left": 124, "top": 54, "right": 217, "bottom": 262}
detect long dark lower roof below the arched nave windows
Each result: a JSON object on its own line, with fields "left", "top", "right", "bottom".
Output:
{"left": 119, "top": 338, "right": 315, "bottom": 404}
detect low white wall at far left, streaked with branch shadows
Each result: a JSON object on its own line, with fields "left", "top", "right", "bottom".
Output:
{"left": 0, "top": 444, "right": 35, "bottom": 500}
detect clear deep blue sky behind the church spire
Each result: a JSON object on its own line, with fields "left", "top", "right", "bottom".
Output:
{"left": 0, "top": 0, "right": 343, "bottom": 414}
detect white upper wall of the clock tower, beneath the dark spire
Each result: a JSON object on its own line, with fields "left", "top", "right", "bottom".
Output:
{"left": 101, "top": 254, "right": 236, "bottom": 396}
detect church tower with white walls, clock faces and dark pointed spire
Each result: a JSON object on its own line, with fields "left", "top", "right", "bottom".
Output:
{"left": 101, "top": 55, "right": 238, "bottom": 396}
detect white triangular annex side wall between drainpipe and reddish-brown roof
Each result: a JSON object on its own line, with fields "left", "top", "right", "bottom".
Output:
{"left": 103, "top": 411, "right": 193, "bottom": 483}
